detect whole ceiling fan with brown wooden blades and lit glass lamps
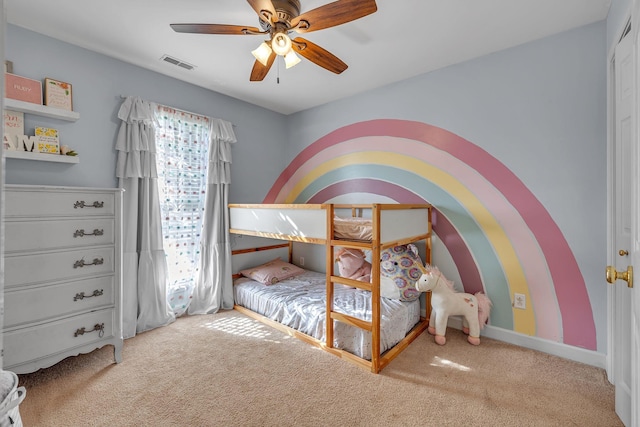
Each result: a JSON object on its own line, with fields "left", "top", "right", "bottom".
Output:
{"left": 171, "top": 0, "right": 378, "bottom": 81}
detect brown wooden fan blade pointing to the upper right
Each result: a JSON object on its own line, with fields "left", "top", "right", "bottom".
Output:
{"left": 291, "top": 0, "right": 378, "bottom": 33}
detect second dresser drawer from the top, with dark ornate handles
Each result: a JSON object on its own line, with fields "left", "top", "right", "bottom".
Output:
{"left": 4, "top": 218, "right": 115, "bottom": 252}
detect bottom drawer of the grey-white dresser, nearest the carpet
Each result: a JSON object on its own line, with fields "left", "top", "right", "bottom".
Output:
{"left": 3, "top": 309, "right": 120, "bottom": 368}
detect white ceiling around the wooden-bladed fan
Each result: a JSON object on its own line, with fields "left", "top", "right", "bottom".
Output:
{"left": 4, "top": 0, "right": 611, "bottom": 114}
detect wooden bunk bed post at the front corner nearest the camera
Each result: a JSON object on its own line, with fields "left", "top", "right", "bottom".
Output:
{"left": 371, "top": 204, "right": 381, "bottom": 374}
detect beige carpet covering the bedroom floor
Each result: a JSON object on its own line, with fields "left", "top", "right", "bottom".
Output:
{"left": 19, "top": 311, "right": 622, "bottom": 427}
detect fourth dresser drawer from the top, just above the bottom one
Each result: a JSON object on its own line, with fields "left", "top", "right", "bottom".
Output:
{"left": 4, "top": 275, "right": 115, "bottom": 328}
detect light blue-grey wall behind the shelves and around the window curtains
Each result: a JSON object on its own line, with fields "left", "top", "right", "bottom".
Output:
{"left": 6, "top": 25, "right": 287, "bottom": 203}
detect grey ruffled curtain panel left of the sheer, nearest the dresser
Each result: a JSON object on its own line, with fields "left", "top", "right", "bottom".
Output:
{"left": 116, "top": 97, "right": 175, "bottom": 338}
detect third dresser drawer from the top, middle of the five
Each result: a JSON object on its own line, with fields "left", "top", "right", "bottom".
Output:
{"left": 4, "top": 247, "right": 115, "bottom": 288}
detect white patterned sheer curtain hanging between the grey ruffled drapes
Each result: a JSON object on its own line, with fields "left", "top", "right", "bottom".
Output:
{"left": 156, "top": 106, "right": 211, "bottom": 316}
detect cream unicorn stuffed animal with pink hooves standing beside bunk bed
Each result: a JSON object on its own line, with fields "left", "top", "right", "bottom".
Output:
{"left": 416, "top": 265, "right": 491, "bottom": 345}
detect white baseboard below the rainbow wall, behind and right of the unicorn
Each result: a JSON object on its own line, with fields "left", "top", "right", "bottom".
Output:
{"left": 440, "top": 316, "right": 607, "bottom": 369}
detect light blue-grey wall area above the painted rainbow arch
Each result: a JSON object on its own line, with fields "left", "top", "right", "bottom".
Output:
{"left": 287, "top": 21, "right": 607, "bottom": 352}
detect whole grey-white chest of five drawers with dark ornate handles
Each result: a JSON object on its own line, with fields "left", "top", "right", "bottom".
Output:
{"left": 3, "top": 185, "right": 123, "bottom": 374}
